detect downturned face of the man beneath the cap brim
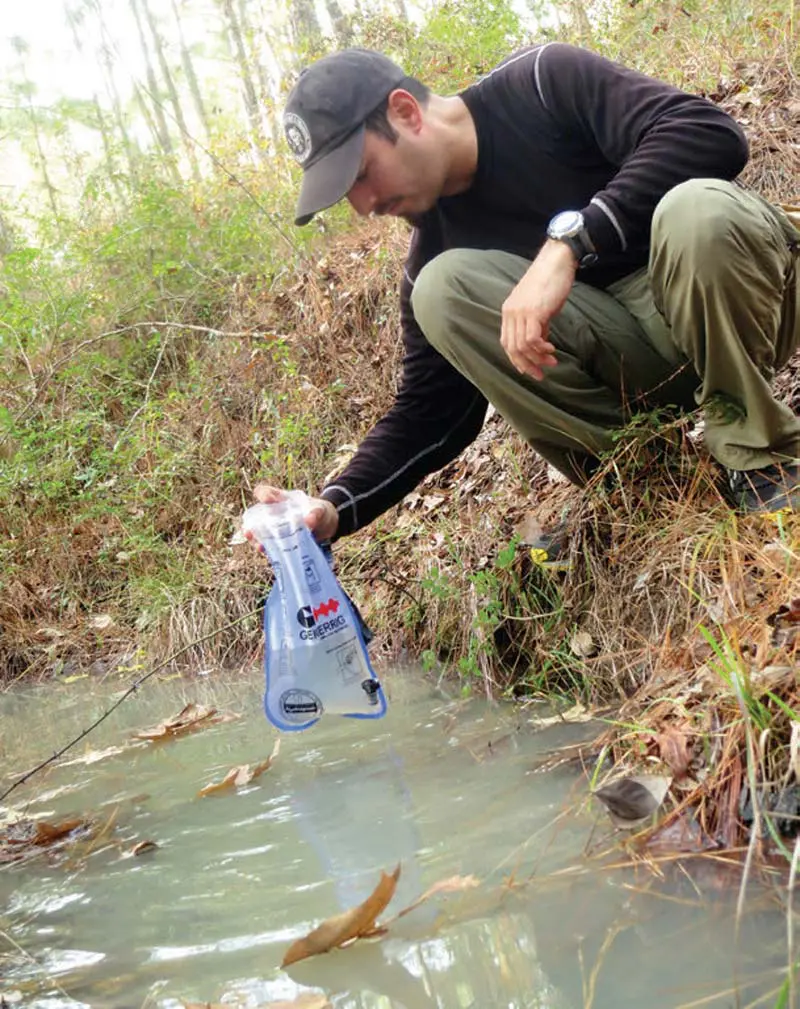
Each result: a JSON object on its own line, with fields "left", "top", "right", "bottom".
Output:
{"left": 347, "top": 98, "right": 444, "bottom": 219}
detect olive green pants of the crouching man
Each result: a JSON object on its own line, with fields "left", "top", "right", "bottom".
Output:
{"left": 412, "top": 179, "right": 800, "bottom": 483}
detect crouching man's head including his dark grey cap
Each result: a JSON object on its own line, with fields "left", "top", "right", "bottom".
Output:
{"left": 283, "top": 49, "right": 441, "bottom": 224}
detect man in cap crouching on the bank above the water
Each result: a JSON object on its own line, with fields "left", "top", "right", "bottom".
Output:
{"left": 256, "top": 42, "right": 800, "bottom": 539}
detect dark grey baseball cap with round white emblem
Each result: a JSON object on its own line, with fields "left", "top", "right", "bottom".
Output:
{"left": 283, "top": 48, "right": 407, "bottom": 224}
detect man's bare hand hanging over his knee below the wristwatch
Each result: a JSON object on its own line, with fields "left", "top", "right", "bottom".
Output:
{"left": 500, "top": 239, "right": 578, "bottom": 379}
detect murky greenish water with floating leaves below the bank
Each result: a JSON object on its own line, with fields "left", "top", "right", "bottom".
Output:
{"left": 0, "top": 671, "right": 787, "bottom": 1009}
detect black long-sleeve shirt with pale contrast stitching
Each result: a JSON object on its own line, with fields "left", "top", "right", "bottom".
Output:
{"left": 323, "top": 42, "right": 748, "bottom": 536}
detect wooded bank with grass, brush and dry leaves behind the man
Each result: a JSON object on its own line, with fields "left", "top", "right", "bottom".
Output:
{"left": 0, "top": 0, "right": 800, "bottom": 843}
